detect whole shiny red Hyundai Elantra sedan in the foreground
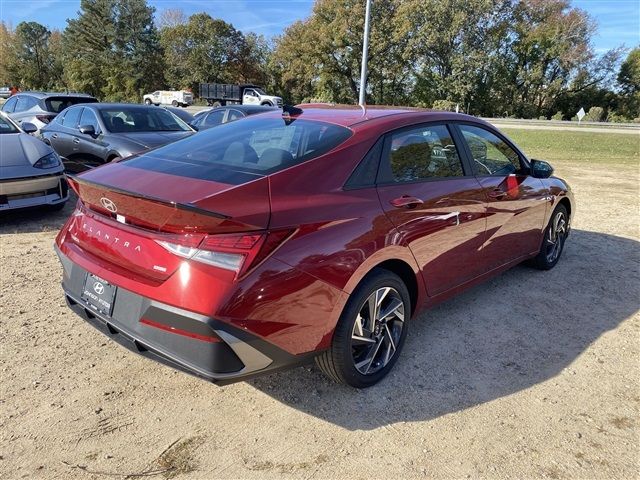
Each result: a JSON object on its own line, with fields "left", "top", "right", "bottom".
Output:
{"left": 56, "top": 105, "right": 575, "bottom": 388}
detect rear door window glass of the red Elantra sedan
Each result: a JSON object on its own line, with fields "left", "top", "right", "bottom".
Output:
{"left": 386, "top": 125, "right": 464, "bottom": 183}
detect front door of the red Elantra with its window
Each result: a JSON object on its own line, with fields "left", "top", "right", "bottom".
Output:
{"left": 458, "top": 124, "right": 549, "bottom": 269}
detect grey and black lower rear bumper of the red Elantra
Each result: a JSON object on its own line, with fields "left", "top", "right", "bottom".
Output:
{"left": 56, "top": 247, "right": 313, "bottom": 384}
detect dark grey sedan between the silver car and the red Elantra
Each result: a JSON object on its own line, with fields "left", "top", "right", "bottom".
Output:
{"left": 40, "top": 103, "right": 194, "bottom": 171}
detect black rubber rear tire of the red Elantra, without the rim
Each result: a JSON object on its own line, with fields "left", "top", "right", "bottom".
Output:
{"left": 332, "top": 269, "right": 411, "bottom": 388}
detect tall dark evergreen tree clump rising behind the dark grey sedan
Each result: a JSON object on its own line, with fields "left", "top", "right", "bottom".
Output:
{"left": 64, "top": 0, "right": 163, "bottom": 101}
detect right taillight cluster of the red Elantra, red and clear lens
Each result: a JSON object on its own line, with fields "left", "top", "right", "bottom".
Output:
{"left": 156, "top": 230, "right": 293, "bottom": 276}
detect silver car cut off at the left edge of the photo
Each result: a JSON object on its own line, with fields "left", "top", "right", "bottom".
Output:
{"left": 0, "top": 112, "right": 69, "bottom": 212}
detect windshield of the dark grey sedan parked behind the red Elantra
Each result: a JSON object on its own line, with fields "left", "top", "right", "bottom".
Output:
{"left": 100, "top": 107, "right": 191, "bottom": 133}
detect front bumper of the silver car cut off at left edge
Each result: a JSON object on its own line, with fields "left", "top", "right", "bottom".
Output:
{"left": 0, "top": 173, "right": 69, "bottom": 211}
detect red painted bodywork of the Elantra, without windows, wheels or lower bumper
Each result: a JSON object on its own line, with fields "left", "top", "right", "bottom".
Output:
{"left": 56, "top": 105, "right": 573, "bottom": 382}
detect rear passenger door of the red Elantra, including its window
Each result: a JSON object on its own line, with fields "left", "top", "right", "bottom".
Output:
{"left": 377, "top": 124, "right": 486, "bottom": 296}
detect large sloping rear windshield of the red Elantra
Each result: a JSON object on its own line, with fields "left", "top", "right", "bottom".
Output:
{"left": 124, "top": 116, "right": 351, "bottom": 184}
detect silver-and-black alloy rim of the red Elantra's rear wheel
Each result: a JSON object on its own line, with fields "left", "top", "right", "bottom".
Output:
{"left": 351, "top": 287, "right": 404, "bottom": 375}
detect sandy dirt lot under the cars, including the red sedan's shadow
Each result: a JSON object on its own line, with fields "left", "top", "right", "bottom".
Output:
{"left": 0, "top": 156, "right": 640, "bottom": 479}
